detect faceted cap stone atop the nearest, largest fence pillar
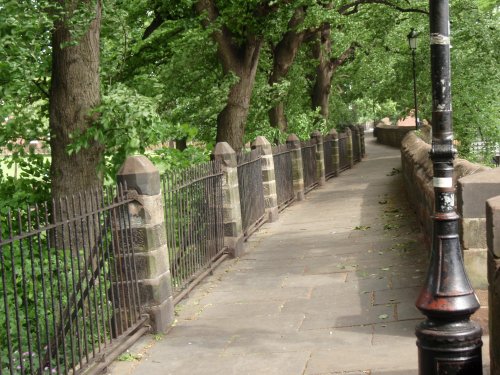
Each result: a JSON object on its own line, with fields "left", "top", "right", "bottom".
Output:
{"left": 116, "top": 155, "right": 161, "bottom": 195}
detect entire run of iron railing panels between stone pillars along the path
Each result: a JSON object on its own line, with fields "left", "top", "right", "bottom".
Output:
{"left": 0, "top": 132, "right": 364, "bottom": 375}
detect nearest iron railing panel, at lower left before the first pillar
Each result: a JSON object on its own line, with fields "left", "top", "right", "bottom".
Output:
{"left": 0, "top": 189, "right": 146, "bottom": 375}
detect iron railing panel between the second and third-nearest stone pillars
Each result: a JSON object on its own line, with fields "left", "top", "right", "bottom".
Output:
{"left": 237, "top": 150, "right": 266, "bottom": 238}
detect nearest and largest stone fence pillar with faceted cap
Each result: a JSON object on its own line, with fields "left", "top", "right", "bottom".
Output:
{"left": 117, "top": 155, "right": 174, "bottom": 332}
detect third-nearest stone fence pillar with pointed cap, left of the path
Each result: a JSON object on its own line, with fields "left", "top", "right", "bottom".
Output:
{"left": 252, "top": 136, "right": 279, "bottom": 222}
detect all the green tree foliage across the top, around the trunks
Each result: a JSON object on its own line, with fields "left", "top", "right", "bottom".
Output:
{"left": 0, "top": 0, "right": 500, "bottom": 214}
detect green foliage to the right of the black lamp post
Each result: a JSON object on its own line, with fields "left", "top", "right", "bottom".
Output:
{"left": 451, "top": 0, "right": 500, "bottom": 164}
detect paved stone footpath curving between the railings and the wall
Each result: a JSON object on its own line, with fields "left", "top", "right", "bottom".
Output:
{"left": 108, "top": 135, "right": 488, "bottom": 375}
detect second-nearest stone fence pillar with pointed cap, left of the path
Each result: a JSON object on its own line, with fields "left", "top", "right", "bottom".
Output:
{"left": 214, "top": 142, "right": 243, "bottom": 257}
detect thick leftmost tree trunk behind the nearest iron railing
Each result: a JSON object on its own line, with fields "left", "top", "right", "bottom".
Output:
{"left": 49, "top": 0, "right": 104, "bottom": 200}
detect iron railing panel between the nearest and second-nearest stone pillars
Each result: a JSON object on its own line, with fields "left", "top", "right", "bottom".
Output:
{"left": 162, "top": 161, "right": 225, "bottom": 296}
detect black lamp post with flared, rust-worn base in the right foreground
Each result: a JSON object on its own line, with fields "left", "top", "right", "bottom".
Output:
{"left": 416, "top": 0, "right": 482, "bottom": 375}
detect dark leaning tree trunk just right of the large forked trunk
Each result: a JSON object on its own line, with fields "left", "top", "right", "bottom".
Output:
{"left": 269, "top": 7, "right": 305, "bottom": 132}
